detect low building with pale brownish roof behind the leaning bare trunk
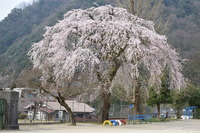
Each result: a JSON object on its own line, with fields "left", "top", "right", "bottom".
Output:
{"left": 24, "top": 100, "right": 95, "bottom": 121}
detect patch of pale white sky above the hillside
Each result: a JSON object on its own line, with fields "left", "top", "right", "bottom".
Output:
{"left": 0, "top": 0, "right": 31, "bottom": 21}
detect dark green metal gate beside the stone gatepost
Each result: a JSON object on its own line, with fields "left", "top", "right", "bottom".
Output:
{"left": 0, "top": 99, "right": 6, "bottom": 130}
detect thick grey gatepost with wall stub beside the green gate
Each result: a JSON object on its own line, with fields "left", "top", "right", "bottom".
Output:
{"left": 0, "top": 90, "right": 19, "bottom": 130}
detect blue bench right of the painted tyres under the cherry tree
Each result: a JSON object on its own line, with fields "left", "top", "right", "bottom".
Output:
{"left": 128, "top": 115, "right": 152, "bottom": 124}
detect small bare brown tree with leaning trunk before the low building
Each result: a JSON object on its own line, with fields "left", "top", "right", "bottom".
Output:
{"left": 18, "top": 65, "right": 95, "bottom": 125}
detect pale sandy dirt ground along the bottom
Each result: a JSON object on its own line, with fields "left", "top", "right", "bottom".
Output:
{"left": 0, "top": 120, "right": 200, "bottom": 133}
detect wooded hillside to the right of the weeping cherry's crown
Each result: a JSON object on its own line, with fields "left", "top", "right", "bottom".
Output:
{"left": 164, "top": 0, "right": 200, "bottom": 86}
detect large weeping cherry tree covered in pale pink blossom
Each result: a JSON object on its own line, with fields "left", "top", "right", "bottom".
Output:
{"left": 29, "top": 5, "right": 184, "bottom": 121}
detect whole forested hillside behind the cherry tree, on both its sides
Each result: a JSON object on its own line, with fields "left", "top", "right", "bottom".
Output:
{"left": 0, "top": 0, "right": 200, "bottom": 87}
